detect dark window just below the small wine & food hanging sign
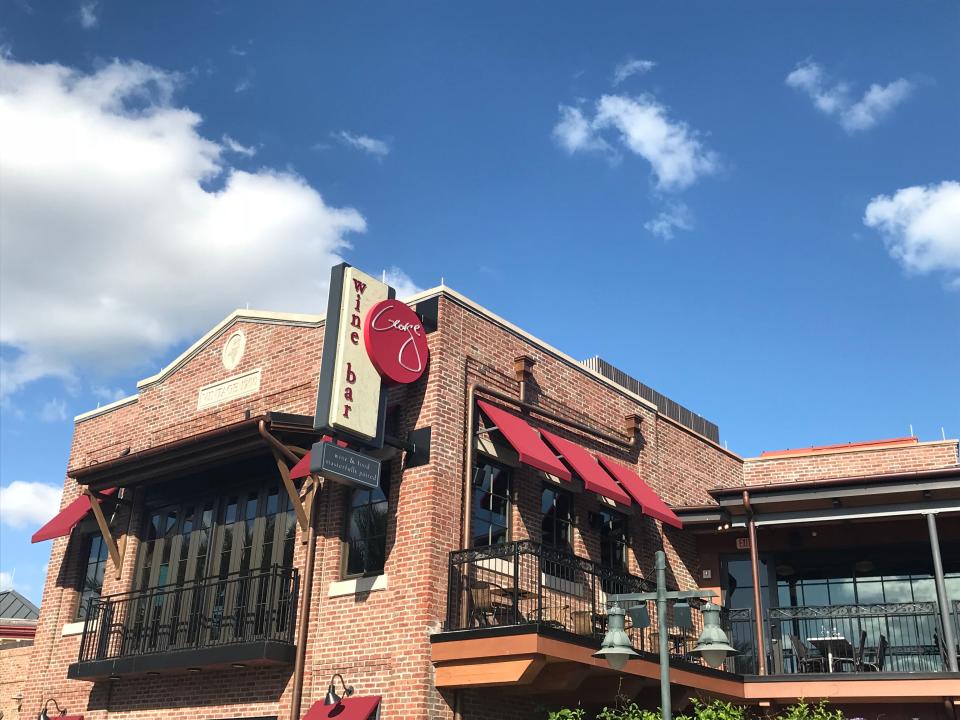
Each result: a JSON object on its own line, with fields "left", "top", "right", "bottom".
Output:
{"left": 343, "top": 464, "right": 390, "bottom": 577}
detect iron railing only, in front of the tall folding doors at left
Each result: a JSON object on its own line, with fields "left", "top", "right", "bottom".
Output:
{"left": 79, "top": 567, "right": 299, "bottom": 662}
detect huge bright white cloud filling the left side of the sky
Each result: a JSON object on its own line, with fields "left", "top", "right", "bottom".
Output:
{"left": 0, "top": 58, "right": 365, "bottom": 400}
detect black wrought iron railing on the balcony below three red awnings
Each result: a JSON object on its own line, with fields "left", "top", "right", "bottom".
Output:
{"left": 445, "top": 540, "right": 702, "bottom": 659}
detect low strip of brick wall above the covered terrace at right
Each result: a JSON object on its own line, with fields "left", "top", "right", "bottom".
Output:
{"left": 743, "top": 440, "right": 957, "bottom": 485}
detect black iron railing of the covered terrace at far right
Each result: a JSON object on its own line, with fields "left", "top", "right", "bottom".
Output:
{"left": 723, "top": 601, "right": 960, "bottom": 675}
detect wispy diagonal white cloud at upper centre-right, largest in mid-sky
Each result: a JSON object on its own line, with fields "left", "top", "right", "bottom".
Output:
{"left": 553, "top": 95, "right": 719, "bottom": 190}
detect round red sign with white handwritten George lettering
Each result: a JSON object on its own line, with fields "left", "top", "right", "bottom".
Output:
{"left": 363, "top": 300, "right": 430, "bottom": 385}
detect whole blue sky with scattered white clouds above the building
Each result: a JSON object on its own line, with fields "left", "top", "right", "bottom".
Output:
{"left": 0, "top": 0, "right": 960, "bottom": 600}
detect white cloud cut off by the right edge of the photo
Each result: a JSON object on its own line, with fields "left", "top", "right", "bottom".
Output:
{"left": 863, "top": 181, "right": 960, "bottom": 288}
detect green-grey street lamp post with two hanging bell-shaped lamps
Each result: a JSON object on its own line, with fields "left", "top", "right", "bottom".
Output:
{"left": 593, "top": 550, "right": 737, "bottom": 720}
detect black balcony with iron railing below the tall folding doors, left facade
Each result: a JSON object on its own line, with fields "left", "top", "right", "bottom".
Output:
{"left": 67, "top": 567, "right": 299, "bottom": 680}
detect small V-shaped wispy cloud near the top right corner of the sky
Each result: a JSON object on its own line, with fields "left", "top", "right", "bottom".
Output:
{"left": 786, "top": 60, "right": 913, "bottom": 133}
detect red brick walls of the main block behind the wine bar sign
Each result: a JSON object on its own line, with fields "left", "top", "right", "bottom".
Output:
{"left": 25, "top": 296, "right": 740, "bottom": 720}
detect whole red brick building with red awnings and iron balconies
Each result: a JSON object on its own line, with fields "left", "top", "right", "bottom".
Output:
{"left": 22, "top": 287, "right": 960, "bottom": 720}
